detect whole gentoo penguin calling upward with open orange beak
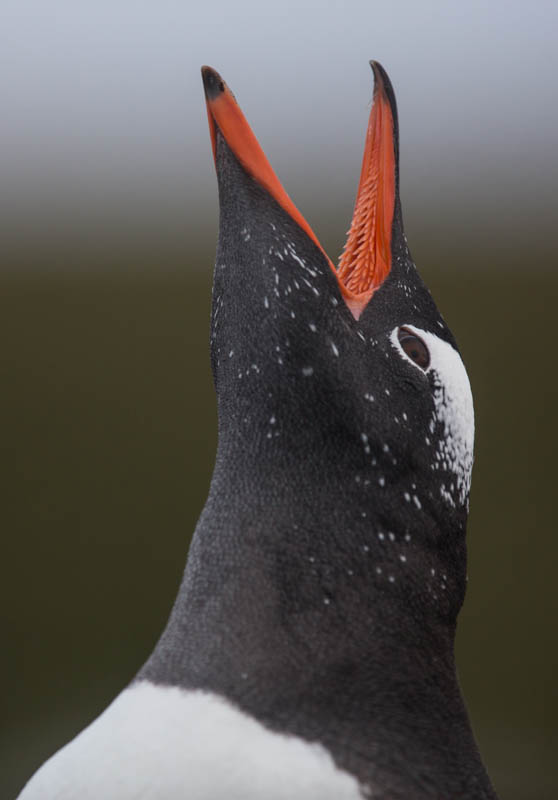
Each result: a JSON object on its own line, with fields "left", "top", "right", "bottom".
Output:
{"left": 20, "top": 62, "right": 496, "bottom": 800}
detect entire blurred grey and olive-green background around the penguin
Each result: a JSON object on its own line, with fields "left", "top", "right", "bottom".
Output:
{"left": 0, "top": 0, "right": 558, "bottom": 800}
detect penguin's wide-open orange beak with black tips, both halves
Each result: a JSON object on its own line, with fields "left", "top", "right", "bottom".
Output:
{"left": 202, "top": 61, "right": 396, "bottom": 320}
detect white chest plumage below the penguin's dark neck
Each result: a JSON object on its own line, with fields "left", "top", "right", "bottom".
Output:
{"left": 19, "top": 681, "right": 364, "bottom": 800}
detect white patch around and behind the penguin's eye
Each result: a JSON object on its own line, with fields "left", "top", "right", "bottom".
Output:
{"left": 390, "top": 323, "right": 475, "bottom": 506}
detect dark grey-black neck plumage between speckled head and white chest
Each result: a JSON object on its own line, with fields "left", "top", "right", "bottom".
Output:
{"left": 139, "top": 450, "right": 493, "bottom": 798}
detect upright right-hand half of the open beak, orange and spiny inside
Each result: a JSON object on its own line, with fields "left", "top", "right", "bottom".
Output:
{"left": 337, "top": 62, "right": 395, "bottom": 319}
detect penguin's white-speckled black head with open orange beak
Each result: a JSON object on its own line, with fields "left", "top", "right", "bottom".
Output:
{"left": 202, "top": 62, "right": 474, "bottom": 620}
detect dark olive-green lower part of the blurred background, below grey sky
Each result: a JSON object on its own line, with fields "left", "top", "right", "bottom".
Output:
{"left": 0, "top": 228, "right": 558, "bottom": 800}
